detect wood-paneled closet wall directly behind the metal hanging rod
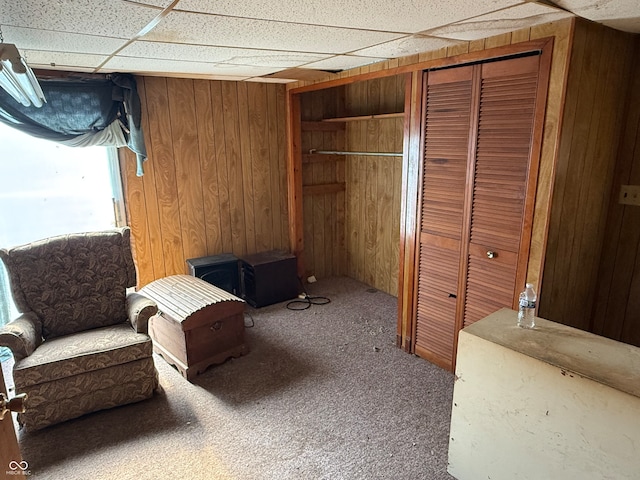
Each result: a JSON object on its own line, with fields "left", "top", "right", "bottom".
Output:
{"left": 345, "top": 75, "right": 405, "bottom": 296}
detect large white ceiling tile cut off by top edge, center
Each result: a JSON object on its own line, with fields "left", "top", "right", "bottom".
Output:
{"left": 164, "top": 0, "right": 525, "bottom": 33}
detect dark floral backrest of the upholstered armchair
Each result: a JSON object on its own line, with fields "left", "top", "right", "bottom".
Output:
{"left": 0, "top": 228, "right": 136, "bottom": 339}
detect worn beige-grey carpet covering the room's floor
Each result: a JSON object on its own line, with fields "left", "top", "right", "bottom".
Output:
{"left": 13, "top": 278, "right": 453, "bottom": 480}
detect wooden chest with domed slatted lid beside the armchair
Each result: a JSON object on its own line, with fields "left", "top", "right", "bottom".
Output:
{"left": 140, "top": 275, "right": 248, "bottom": 380}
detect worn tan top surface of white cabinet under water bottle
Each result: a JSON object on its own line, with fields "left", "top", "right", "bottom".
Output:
{"left": 463, "top": 309, "right": 640, "bottom": 397}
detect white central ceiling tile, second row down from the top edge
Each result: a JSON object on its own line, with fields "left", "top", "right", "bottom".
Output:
{"left": 144, "top": 13, "right": 402, "bottom": 54}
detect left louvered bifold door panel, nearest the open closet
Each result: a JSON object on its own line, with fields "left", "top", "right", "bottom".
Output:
{"left": 415, "top": 67, "right": 473, "bottom": 369}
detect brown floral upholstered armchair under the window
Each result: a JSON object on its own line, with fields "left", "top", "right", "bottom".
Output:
{"left": 0, "top": 227, "right": 158, "bottom": 430}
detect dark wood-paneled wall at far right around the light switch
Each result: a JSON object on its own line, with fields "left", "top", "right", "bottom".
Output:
{"left": 593, "top": 36, "right": 640, "bottom": 346}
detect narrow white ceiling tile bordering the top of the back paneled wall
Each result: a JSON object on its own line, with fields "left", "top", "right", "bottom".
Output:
{"left": 101, "top": 56, "right": 280, "bottom": 78}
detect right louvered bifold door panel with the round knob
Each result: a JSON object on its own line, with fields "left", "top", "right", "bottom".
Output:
{"left": 462, "top": 55, "right": 540, "bottom": 327}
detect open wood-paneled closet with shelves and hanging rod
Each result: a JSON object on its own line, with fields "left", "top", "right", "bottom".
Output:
{"left": 297, "top": 75, "right": 406, "bottom": 296}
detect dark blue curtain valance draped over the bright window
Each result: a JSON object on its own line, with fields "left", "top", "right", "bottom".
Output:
{"left": 0, "top": 73, "right": 147, "bottom": 175}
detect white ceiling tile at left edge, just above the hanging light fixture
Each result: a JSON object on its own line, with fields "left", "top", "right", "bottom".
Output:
{"left": 2, "top": 26, "right": 126, "bottom": 55}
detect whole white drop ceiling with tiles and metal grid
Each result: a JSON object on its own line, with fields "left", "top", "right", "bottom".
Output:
{"left": 0, "top": 0, "right": 640, "bottom": 82}
